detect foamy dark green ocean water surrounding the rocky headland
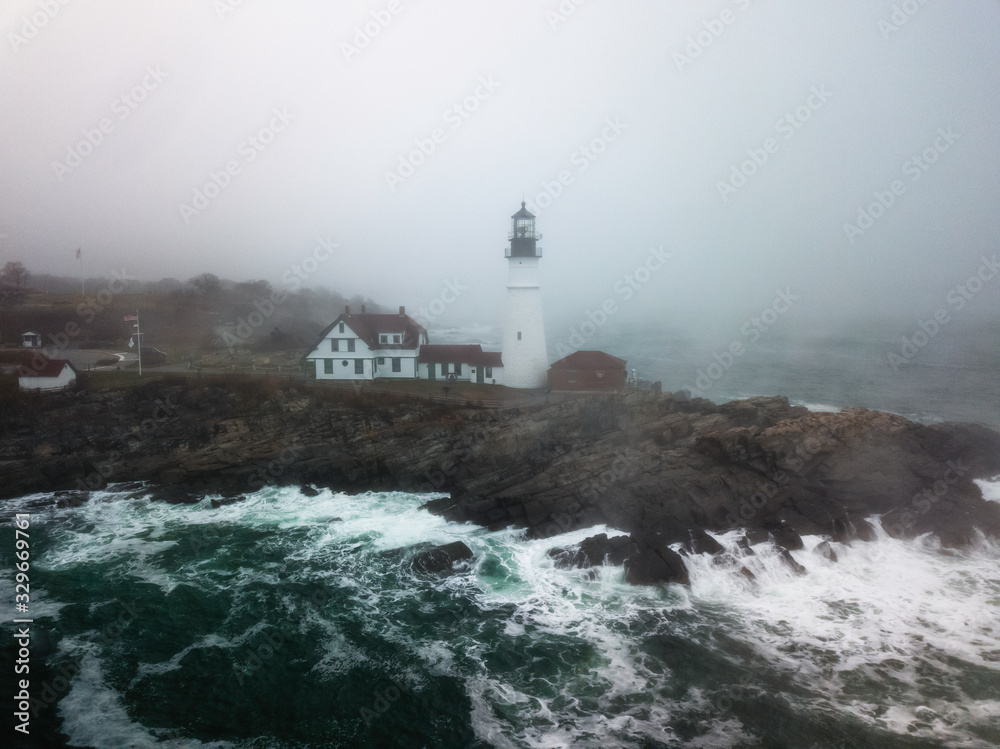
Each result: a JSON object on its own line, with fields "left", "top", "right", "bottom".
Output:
{"left": 0, "top": 328, "right": 1000, "bottom": 749}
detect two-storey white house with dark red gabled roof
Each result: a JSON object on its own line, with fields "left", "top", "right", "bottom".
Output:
{"left": 304, "top": 307, "right": 427, "bottom": 380}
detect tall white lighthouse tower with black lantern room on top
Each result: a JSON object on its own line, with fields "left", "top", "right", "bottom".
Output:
{"left": 503, "top": 201, "right": 549, "bottom": 388}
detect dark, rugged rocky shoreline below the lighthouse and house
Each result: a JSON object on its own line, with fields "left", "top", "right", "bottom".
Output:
{"left": 0, "top": 376, "right": 1000, "bottom": 583}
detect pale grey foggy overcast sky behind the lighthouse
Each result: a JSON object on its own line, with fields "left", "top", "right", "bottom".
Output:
{"left": 0, "top": 0, "right": 1000, "bottom": 328}
